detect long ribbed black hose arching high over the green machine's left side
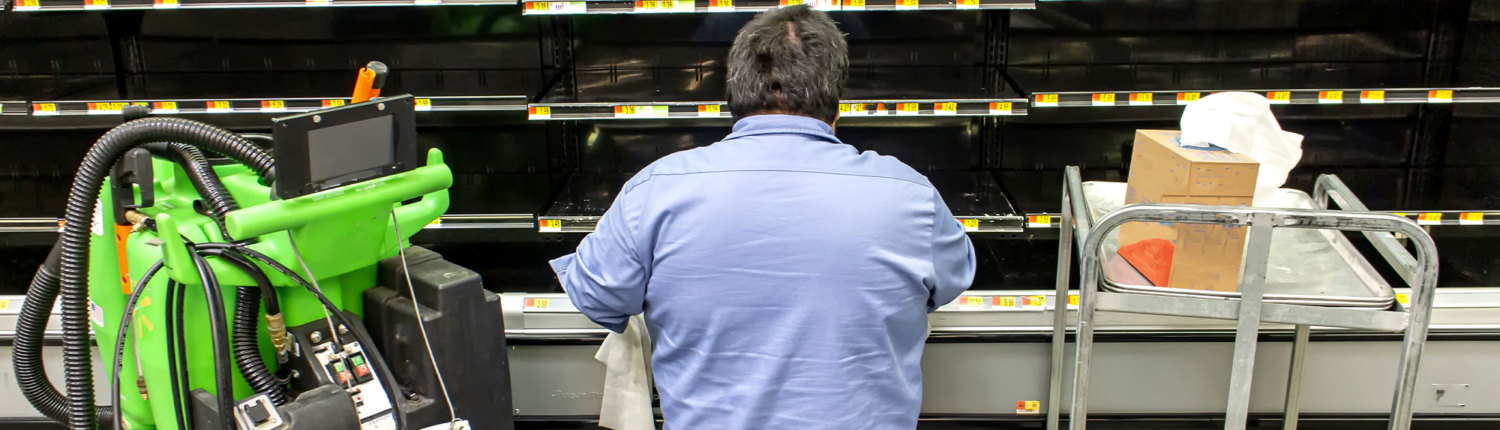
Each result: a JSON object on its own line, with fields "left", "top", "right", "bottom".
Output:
{"left": 27, "top": 118, "right": 273, "bottom": 430}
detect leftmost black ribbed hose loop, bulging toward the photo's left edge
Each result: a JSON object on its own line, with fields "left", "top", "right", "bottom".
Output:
{"left": 11, "top": 241, "right": 114, "bottom": 423}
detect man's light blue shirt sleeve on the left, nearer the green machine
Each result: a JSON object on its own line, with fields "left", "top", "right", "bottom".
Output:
{"left": 552, "top": 181, "right": 650, "bottom": 333}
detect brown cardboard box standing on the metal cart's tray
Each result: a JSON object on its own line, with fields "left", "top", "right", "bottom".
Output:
{"left": 1119, "top": 130, "right": 1260, "bottom": 291}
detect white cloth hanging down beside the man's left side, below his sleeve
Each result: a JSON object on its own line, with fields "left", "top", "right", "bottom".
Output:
{"left": 594, "top": 315, "right": 656, "bottom": 430}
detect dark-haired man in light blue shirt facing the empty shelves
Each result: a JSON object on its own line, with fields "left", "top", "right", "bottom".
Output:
{"left": 552, "top": 6, "right": 975, "bottom": 430}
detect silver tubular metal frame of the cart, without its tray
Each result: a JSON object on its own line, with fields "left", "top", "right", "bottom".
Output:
{"left": 1047, "top": 166, "right": 1437, "bottom": 430}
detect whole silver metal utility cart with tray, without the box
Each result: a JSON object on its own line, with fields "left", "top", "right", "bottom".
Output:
{"left": 1047, "top": 166, "right": 1437, "bottom": 430}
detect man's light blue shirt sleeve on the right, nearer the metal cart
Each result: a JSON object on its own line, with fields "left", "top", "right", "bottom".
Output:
{"left": 927, "top": 190, "right": 975, "bottom": 312}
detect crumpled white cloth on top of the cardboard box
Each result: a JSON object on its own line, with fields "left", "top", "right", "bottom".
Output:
{"left": 1182, "top": 93, "right": 1302, "bottom": 207}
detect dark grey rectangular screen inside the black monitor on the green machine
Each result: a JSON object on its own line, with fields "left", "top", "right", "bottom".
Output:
{"left": 308, "top": 115, "right": 396, "bottom": 184}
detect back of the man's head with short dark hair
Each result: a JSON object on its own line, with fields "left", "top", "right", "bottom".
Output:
{"left": 728, "top": 4, "right": 849, "bottom": 123}
